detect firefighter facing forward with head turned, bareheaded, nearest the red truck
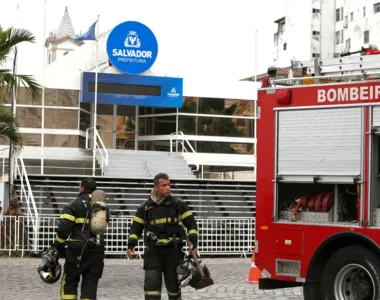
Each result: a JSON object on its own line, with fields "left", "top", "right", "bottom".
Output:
{"left": 127, "top": 173, "right": 198, "bottom": 300}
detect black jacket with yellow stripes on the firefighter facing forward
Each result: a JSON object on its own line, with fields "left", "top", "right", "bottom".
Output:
{"left": 128, "top": 190, "right": 198, "bottom": 249}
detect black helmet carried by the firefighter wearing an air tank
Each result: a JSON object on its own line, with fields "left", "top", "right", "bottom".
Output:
{"left": 38, "top": 248, "right": 62, "bottom": 284}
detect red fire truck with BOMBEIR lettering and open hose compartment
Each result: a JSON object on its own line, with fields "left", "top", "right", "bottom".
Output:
{"left": 254, "top": 55, "right": 380, "bottom": 300}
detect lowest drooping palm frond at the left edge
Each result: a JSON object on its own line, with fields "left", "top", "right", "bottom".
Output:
{"left": 0, "top": 106, "right": 23, "bottom": 152}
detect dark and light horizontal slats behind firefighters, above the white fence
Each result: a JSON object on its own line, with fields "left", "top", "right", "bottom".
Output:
{"left": 15, "top": 175, "right": 256, "bottom": 218}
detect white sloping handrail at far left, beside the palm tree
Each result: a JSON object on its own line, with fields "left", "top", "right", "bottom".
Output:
{"left": 13, "top": 154, "right": 39, "bottom": 250}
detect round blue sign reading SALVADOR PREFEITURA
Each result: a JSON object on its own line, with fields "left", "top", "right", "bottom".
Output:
{"left": 107, "top": 21, "right": 158, "bottom": 75}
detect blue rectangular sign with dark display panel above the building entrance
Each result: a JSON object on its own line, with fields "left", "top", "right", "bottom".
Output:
{"left": 81, "top": 72, "right": 183, "bottom": 108}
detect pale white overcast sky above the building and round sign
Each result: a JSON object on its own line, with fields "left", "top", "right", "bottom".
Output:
{"left": 0, "top": 0, "right": 284, "bottom": 84}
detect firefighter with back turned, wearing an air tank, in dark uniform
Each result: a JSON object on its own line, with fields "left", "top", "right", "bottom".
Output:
{"left": 51, "top": 178, "right": 109, "bottom": 300}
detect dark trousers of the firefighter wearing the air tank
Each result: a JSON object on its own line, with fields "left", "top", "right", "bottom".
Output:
{"left": 61, "top": 249, "right": 104, "bottom": 300}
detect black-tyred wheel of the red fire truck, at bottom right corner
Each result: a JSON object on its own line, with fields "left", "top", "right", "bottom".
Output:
{"left": 321, "top": 246, "right": 380, "bottom": 300}
